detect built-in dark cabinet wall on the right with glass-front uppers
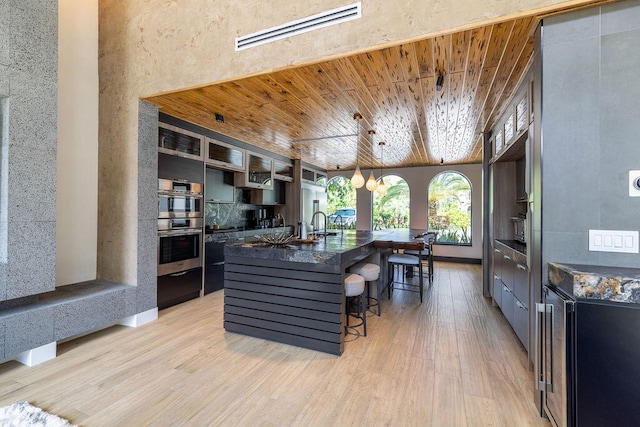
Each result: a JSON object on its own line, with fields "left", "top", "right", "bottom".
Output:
{"left": 484, "top": 66, "right": 536, "bottom": 367}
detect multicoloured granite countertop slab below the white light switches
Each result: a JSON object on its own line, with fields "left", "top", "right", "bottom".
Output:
{"left": 549, "top": 262, "right": 640, "bottom": 304}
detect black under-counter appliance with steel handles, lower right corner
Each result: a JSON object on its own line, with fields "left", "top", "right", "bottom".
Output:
{"left": 538, "top": 285, "right": 640, "bottom": 427}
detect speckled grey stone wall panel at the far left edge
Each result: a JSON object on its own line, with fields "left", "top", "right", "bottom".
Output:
{"left": 0, "top": 0, "right": 58, "bottom": 302}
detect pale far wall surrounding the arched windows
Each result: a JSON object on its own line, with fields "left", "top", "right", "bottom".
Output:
{"left": 328, "top": 165, "right": 483, "bottom": 259}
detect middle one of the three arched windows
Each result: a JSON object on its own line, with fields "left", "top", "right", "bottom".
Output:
{"left": 373, "top": 175, "right": 410, "bottom": 230}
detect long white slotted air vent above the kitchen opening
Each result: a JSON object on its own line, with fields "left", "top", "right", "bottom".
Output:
{"left": 236, "top": 2, "right": 362, "bottom": 51}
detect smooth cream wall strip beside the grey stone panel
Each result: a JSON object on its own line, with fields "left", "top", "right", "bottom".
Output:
{"left": 56, "top": 0, "right": 98, "bottom": 286}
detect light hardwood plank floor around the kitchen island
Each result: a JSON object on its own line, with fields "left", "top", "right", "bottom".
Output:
{"left": 0, "top": 263, "right": 548, "bottom": 426}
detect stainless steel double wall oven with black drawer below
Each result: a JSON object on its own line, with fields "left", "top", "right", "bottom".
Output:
{"left": 158, "top": 179, "right": 204, "bottom": 309}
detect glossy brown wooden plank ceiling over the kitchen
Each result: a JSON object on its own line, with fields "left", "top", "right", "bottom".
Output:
{"left": 146, "top": 17, "right": 538, "bottom": 170}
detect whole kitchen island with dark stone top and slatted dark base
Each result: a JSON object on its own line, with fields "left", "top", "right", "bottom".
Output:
{"left": 224, "top": 230, "right": 419, "bottom": 355}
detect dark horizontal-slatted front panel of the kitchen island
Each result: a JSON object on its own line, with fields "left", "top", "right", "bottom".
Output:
{"left": 224, "top": 254, "right": 345, "bottom": 355}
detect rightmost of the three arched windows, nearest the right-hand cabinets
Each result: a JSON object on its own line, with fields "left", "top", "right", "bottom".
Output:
{"left": 427, "top": 171, "right": 471, "bottom": 246}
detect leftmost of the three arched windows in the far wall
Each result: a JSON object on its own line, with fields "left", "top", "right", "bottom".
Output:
{"left": 327, "top": 176, "right": 356, "bottom": 229}
